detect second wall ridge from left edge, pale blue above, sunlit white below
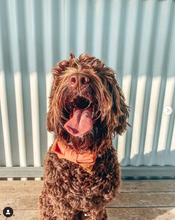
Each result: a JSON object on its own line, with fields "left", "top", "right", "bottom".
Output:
{"left": 8, "top": 0, "right": 27, "bottom": 180}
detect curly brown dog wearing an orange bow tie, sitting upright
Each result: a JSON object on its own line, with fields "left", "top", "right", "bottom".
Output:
{"left": 39, "top": 53, "right": 129, "bottom": 220}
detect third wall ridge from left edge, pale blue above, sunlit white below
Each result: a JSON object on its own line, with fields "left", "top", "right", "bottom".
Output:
{"left": 25, "top": 0, "right": 41, "bottom": 172}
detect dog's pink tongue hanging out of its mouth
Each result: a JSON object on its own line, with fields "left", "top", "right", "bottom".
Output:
{"left": 64, "top": 108, "right": 93, "bottom": 136}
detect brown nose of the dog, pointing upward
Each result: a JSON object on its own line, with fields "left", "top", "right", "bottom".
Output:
{"left": 70, "top": 73, "right": 89, "bottom": 91}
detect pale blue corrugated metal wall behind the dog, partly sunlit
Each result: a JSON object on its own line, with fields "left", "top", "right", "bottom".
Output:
{"left": 0, "top": 0, "right": 175, "bottom": 178}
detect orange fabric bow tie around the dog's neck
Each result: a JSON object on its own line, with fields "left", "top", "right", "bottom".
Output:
{"left": 52, "top": 140, "right": 97, "bottom": 173}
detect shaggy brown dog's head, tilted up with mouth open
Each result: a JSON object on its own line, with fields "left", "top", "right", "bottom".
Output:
{"left": 47, "top": 53, "right": 129, "bottom": 152}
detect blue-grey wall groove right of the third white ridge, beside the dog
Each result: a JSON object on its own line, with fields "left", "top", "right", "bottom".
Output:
{"left": 33, "top": 1, "right": 47, "bottom": 168}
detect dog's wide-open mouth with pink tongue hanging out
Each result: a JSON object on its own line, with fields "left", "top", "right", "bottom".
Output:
{"left": 64, "top": 96, "right": 95, "bottom": 136}
